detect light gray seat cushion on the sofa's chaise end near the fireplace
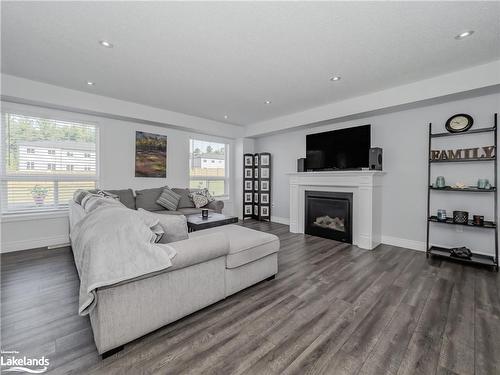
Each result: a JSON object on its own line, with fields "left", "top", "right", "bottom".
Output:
{"left": 189, "top": 224, "right": 280, "bottom": 268}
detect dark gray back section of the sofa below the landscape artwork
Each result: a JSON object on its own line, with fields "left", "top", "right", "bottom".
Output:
{"left": 96, "top": 187, "right": 224, "bottom": 216}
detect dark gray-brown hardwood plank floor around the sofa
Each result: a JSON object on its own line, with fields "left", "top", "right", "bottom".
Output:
{"left": 1, "top": 221, "right": 500, "bottom": 375}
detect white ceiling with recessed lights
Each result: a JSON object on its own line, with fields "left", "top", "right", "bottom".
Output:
{"left": 1, "top": 1, "right": 500, "bottom": 125}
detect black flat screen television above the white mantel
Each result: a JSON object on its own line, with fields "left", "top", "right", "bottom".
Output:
{"left": 306, "top": 125, "right": 371, "bottom": 171}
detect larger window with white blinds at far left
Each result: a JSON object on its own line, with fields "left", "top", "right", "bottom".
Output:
{"left": 0, "top": 113, "right": 98, "bottom": 214}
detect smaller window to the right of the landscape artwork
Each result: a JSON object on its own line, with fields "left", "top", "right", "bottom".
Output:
{"left": 189, "top": 139, "right": 229, "bottom": 197}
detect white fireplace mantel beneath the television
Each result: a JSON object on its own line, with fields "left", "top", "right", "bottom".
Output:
{"left": 288, "top": 171, "right": 384, "bottom": 250}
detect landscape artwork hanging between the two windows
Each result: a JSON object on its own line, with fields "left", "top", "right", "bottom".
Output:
{"left": 135, "top": 131, "right": 167, "bottom": 178}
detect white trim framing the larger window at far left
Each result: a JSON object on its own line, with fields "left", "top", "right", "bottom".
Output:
{"left": 0, "top": 110, "right": 101, "bottom": 217}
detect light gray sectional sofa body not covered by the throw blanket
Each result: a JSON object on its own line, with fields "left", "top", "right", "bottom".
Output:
{"left": 70, "top": 189, "right": 280, "bottom": 358}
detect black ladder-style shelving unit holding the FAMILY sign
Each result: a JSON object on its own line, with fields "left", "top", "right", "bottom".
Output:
{"left": 426, "top": 113, "right": 498, "bottom": 271}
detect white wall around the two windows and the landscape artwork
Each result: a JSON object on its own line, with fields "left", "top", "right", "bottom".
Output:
{"left": 1, "top": 102, "right": 235, "bottom": 252}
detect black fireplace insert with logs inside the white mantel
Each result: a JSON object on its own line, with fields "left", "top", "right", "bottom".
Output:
{"left": 304, "top": 191, "right": 352, "bottom": 243}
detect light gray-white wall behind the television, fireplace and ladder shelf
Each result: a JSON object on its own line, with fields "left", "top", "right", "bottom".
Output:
{"left": 255, "top": 94, "right": 500, "bottom": 253}
